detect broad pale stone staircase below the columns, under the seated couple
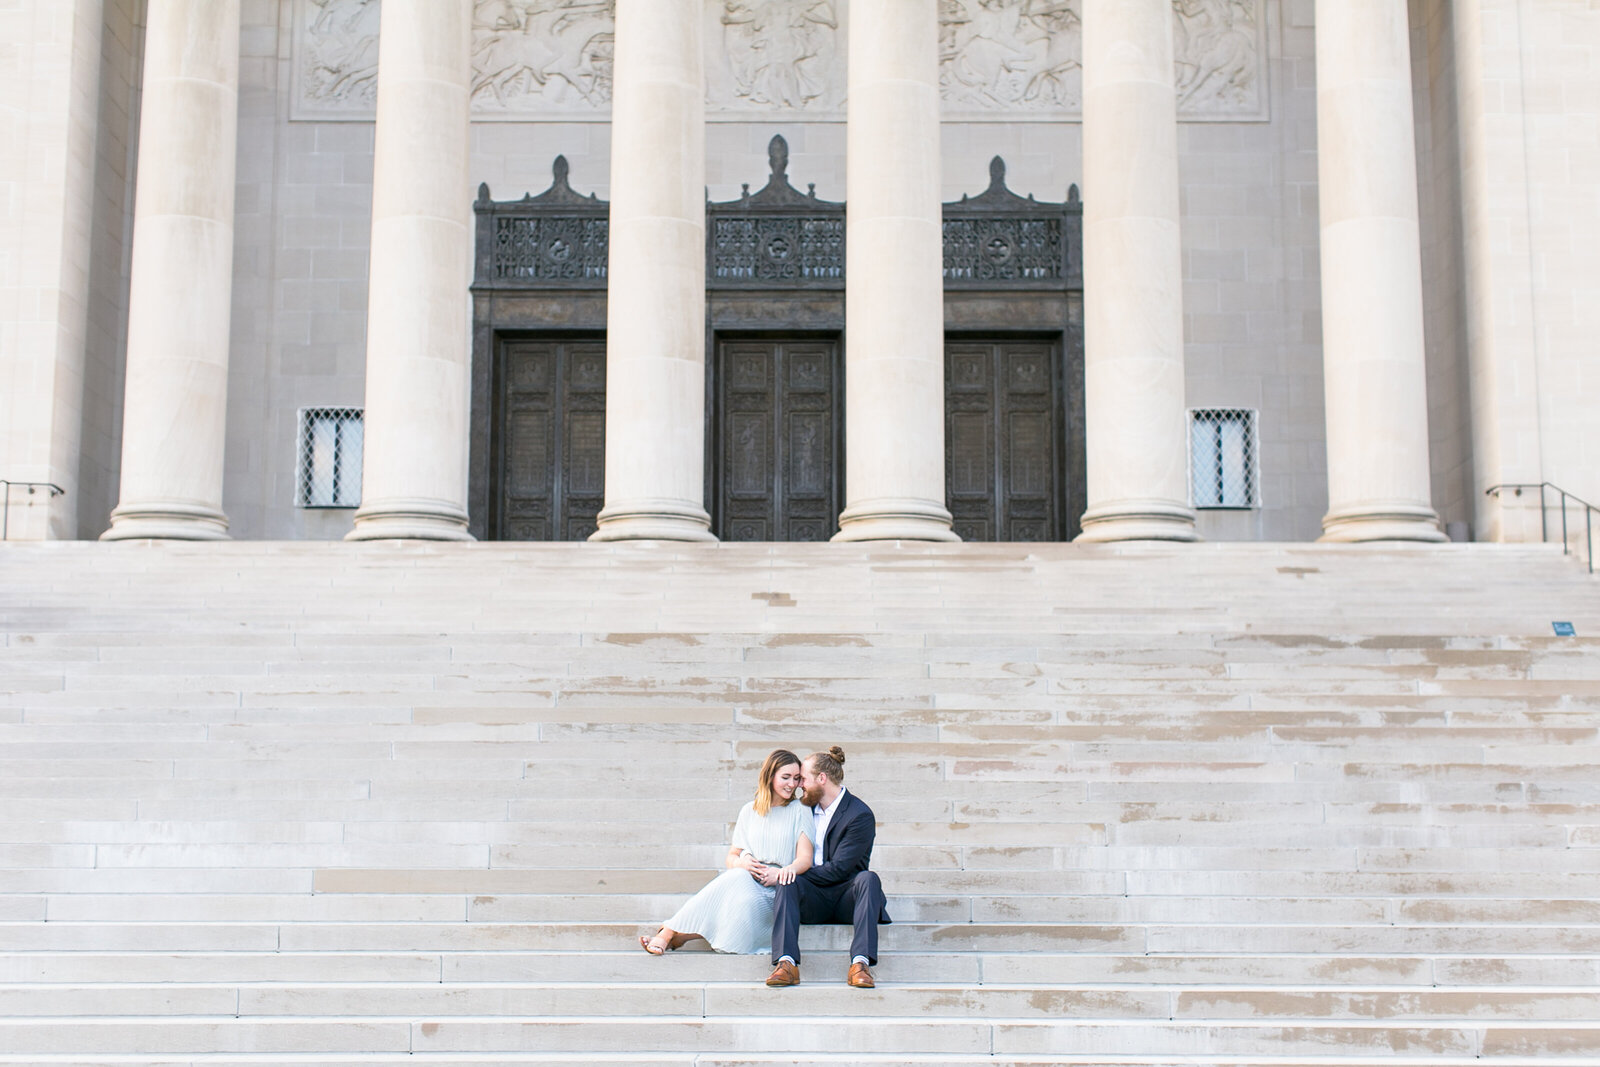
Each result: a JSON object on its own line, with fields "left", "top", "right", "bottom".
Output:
{"left": 0, "top": 544, "right": 1600, "bottom": 1067}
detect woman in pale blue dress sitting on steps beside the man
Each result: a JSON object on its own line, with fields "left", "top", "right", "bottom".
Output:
{"left": 638, "top": 749, "right": 813, "bottom": 957}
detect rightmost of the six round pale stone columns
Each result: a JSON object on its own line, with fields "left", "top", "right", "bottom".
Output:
{"left": 1317, "top": 0, "right": 1445, "bottom": 541}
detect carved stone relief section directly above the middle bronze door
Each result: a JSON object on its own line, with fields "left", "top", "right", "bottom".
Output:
{"left": 722, "top": 0, "right": 838, "bottom": 110}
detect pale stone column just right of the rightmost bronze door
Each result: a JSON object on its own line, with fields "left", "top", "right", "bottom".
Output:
{"left": 1078, "top": 0, "right": 1195, "bottom": 541}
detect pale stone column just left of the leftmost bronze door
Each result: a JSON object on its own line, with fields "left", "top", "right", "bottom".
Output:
{"left": 346, "top": 0, "right": 472, "bottom": 541}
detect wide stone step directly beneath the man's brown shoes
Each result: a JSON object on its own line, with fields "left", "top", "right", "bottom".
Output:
{"left": 0, "top": 966, "right": 1594, "bottom": 1024}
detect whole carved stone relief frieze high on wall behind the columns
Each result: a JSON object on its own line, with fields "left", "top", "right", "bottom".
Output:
{"left": 291, "top": 0, "right": 1269, "bottom": 122}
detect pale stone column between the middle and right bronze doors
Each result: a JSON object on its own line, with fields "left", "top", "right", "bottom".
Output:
{"left": 834, "top": 0, "right": 960, "bottom": 541}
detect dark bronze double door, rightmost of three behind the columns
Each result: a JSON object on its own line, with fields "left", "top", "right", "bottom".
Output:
{"left": 944, "top": 341, "right": 1067, "bottom": 541}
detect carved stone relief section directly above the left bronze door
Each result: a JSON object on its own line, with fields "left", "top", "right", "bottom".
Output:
{"left": 472, "top": 0, "right": 616, "bottom": 110}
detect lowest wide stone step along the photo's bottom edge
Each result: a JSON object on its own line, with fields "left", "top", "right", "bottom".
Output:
{"left": 0, "top": 1017, "right": 1600, "bottom": 1062}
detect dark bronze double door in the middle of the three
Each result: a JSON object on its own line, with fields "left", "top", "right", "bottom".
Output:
{"left": 714, "top": 341, "right": 840, "bottom": 541}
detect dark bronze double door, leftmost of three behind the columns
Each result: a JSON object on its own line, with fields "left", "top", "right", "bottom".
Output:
{"left": 490, "top": 341, "right": 605, "bottom": 541}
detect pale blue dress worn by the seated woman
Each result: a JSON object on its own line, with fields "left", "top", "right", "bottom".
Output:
{"left": 667, "top": 800, "right": 816, "bottom": 952}
